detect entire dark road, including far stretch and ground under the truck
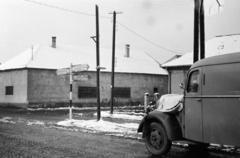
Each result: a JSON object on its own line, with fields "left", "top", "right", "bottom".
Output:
{"left": 0, "top": 110, "right": 240, "bottom": 158}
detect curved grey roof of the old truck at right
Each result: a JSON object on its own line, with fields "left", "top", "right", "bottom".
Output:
{"left": 191, "top": 52, "right": 240, "bottom": 68}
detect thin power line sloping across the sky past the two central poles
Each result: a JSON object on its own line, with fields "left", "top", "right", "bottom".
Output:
{"left": 24, "top": 0, "right": 180, "bottom": 54}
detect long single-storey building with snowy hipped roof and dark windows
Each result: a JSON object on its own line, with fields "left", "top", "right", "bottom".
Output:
{"left": 0, "top": 37, "right": 167, "bottom": 106}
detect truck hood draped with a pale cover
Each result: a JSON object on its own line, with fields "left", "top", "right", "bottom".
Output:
{"left": 156, "top": 94, "right": 183, "bottom": 112}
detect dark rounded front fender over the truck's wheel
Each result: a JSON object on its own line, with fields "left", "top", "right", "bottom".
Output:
{"left": 138, "top": 110, "right": 182, "bottom": 140}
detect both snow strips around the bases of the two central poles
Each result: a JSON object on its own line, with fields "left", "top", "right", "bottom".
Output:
{"left": 57, "top": 111, "right": 143, "bottom": 138}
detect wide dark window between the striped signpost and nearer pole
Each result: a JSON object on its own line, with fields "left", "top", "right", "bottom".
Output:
{"left": 78, "top": 87, "right": 97, "bottom": 98}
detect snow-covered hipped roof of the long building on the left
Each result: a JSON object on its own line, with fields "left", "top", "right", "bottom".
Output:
{"left": 0, "top": 45, "right": 167, "bottom": 75}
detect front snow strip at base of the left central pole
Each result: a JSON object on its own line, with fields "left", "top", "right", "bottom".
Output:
{"left": 57, "top": 119, "right": 138, "bottom": 134}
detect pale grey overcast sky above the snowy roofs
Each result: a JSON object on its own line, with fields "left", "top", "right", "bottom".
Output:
{"left": 0, "top": 0, "right": 240, "bottom": 62}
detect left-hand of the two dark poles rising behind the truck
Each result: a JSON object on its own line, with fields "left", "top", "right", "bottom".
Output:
{"left": 193, "top": 0, "right": 200, "bottom": 63}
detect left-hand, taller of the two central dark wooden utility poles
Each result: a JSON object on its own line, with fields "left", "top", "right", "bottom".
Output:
{"left": 95, "top": 5, "right": 101, "bottom": 121}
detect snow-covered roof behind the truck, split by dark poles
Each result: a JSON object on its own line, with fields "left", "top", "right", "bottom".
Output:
{"left": 162, "top": 34, "right": 240, "bottom": 68}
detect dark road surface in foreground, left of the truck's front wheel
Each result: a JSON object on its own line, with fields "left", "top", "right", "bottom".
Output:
{"left": 0, "top": 124, "right": 147, "bottom": 158}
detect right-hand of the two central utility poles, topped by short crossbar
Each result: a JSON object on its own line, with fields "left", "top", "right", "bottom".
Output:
{"left": 110, "top": 11, "right": 120, "bottom": 114}
